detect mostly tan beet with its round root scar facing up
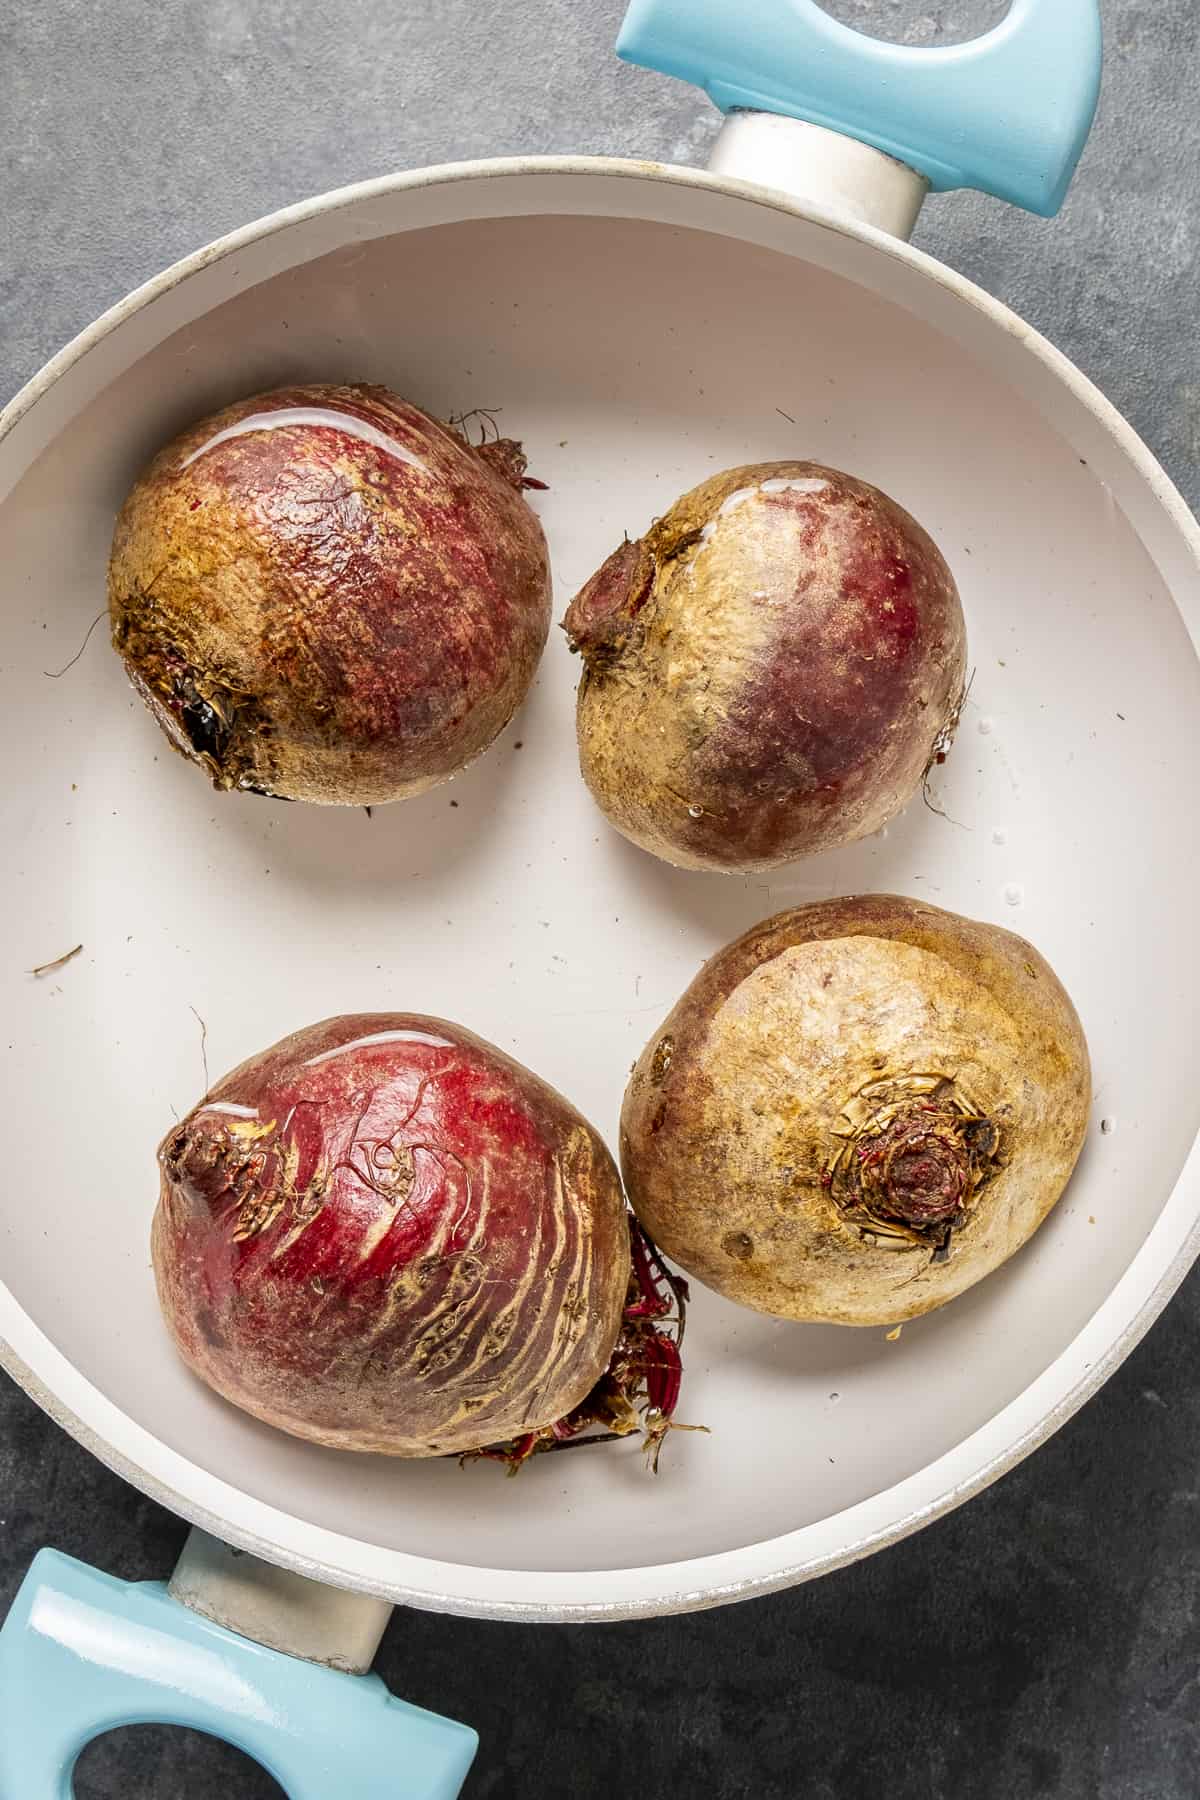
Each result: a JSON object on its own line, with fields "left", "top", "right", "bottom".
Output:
{"left": 621, "top": 895, "right": 1090, "bottom": 1325}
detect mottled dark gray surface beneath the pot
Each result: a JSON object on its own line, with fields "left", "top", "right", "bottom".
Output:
{"left": 0, "top": 0, "right": 1200, "bottom": 1800}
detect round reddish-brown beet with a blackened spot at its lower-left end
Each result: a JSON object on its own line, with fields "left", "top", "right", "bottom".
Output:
{"left": 108, "top": 387, "right": 551, "bottom": 806}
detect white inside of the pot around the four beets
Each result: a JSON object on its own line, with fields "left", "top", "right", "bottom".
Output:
{"left": 0, "top": 189, "right": 1200, "bottom": 1591}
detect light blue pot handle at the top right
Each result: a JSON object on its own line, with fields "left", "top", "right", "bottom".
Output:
{"left": 617, "top": 0, "right": 1103, "bottom": 218}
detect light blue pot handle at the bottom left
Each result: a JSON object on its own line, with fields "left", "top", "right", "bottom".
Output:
{"left": 0, "top": 1550, "right": 477, "bottom": 1800}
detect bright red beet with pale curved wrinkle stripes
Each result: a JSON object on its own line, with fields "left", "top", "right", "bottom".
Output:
{"left": 153, "top": 1013, "right": 630, "bottom": 1456}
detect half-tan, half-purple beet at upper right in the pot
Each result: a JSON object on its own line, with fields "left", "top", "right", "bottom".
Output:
{"left": 563, "top": 463, "right": 966, "bottom": 869}
